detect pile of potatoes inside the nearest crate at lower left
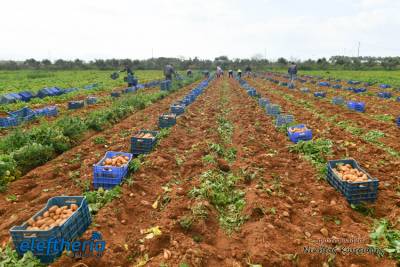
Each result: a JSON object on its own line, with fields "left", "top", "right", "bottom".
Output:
{"left": 26, "top": 204, "right": 78, "bottom": 231}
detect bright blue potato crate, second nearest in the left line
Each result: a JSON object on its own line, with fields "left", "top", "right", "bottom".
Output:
{"left": 93, "top": 151, "right": 133, "bottom": 189}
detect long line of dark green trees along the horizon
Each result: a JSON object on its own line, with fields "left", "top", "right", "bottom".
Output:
{"left": 0, "top": 56, "right": 400, "bottom": 70}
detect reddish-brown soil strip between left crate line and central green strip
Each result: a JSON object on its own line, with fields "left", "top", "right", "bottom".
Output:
{"left": 50, "top": 76, "right": 225, "bottom": 266}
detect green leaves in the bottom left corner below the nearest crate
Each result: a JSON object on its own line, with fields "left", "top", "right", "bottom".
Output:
{"left": 0, "top": 246, "right": 44, "bottom": 267}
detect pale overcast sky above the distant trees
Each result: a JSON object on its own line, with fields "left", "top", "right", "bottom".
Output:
{"left": 0, "top": 0, "right": 400, "bottom": 60}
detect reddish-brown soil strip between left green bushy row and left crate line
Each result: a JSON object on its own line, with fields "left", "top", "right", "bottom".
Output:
{"left": 0, "top": 81, "right": 202, "bottom": 247}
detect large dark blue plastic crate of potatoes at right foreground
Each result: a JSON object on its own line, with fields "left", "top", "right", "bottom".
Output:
{"left": 327, "top": 159, "right": 379, "bottom": 204}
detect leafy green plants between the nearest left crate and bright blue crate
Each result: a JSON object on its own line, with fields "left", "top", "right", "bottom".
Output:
{"left": 83, "top": 186, "right": 122, "bottom": 214}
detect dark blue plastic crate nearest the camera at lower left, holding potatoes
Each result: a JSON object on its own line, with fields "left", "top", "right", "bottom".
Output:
{"left": 10, "top": 196, "right": 92, "bottom": 263}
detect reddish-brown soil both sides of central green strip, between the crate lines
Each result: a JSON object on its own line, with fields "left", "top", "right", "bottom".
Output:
{"left": 55, "top": 76, "right": 394, "bottom": 266}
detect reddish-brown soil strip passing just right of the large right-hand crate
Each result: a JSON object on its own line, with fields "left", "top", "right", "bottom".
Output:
{"left": 250, "top": 77, "right": 400, "bottom": 218}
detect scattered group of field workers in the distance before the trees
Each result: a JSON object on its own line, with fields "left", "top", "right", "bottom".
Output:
{"left": 119, "top": 62, "right": 297, "bottom": 87}
